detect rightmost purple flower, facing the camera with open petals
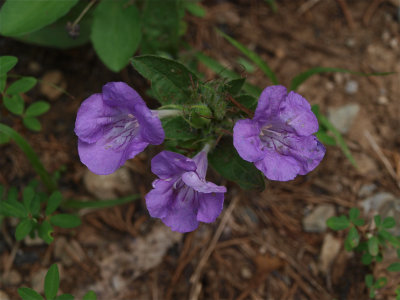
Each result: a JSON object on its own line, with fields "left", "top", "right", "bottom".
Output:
{"left": 233, "top": 85, "right": 326, "bottom": 181}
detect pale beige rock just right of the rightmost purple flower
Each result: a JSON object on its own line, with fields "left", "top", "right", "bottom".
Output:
{"left": 328, "top": 103, "right": 360, "bottom": 134}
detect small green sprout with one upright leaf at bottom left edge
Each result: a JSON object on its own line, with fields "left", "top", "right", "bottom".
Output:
{"left": 18, "top": 264, "right": 97, "bottom": 300}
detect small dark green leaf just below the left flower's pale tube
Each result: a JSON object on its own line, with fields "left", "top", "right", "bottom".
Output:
{"left": 161, "top": 117, "right": 197, "bottom": 140}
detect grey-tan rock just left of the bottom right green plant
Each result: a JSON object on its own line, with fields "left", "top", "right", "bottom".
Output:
{"left": 303, "top": 204, "right": 335, "bottom": 232}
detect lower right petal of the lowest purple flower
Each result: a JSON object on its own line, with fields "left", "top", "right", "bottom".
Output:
{"left": 197, "top": 193, "right": 224, "bottom": 223}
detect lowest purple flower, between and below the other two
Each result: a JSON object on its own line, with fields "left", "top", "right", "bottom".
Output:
{"left": 146, "top": 151, "right": 226, "bottom": 232}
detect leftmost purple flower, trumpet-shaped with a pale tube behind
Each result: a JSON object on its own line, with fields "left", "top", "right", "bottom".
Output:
{"left": 75, "top": 82, "right": 164, "bottom": 175}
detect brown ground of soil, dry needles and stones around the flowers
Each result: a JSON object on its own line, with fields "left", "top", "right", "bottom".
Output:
{"left": 0, "top": 0, "right": 400, "bottom": 300}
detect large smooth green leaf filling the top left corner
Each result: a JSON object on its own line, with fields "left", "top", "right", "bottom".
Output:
{"left": 0, "top": 0, "right": 78, "bottom": 36}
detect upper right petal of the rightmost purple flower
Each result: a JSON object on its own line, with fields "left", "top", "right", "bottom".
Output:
{"left": 279, "top": 92, "right": 318, "bottom": 136}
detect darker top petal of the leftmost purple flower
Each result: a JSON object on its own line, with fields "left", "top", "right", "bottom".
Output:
{"left": 102, "top": 82, "right": 146, "bottom": 113}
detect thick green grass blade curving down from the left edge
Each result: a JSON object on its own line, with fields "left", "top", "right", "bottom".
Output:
{"left": 0, "top": 124, "right": 56, "bottom": 191}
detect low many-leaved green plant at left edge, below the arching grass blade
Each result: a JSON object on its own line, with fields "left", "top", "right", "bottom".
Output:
{"left": 0, "top": 181, "right": 81, "bottom": 244}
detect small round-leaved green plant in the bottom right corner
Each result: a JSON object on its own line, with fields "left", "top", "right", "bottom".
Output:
{"left": 326, "top": 207, "right": 400, "bottom": 299}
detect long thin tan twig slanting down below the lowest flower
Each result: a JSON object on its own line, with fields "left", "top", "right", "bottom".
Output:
{"left": 189, "top": 196, "right": 239, "bottom": 300}
